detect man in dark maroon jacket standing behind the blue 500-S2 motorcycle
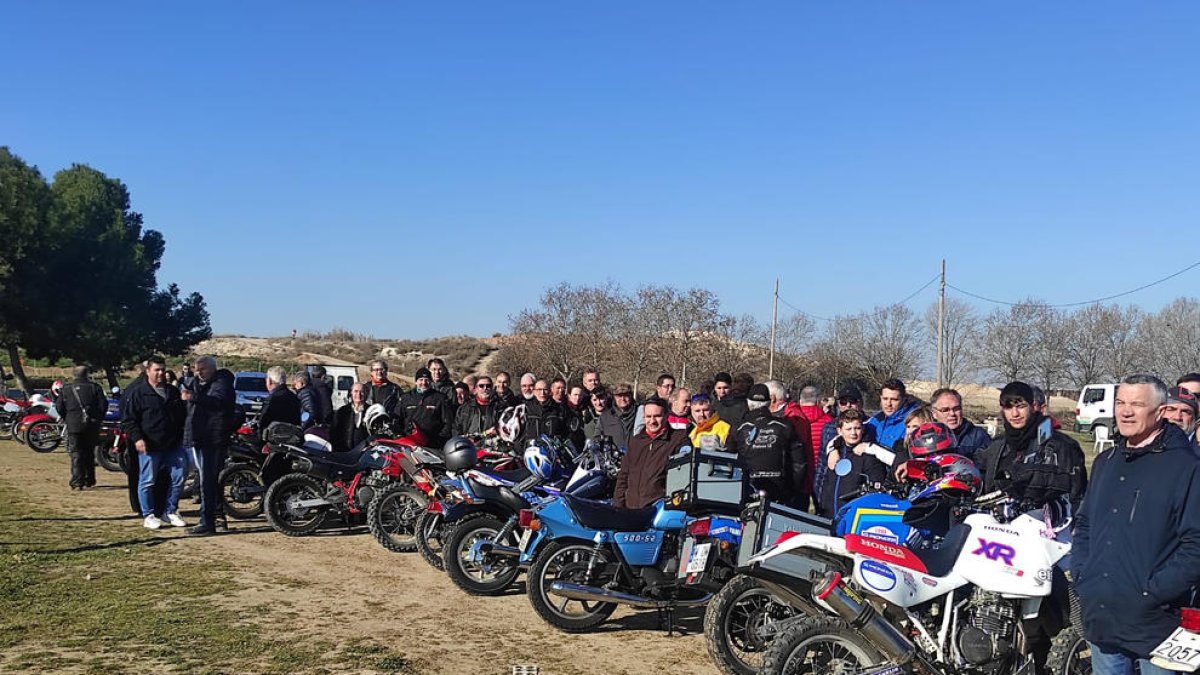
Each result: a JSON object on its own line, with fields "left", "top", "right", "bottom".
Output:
{"left": 612, "top": 399, "right": 688, "bottom": 509}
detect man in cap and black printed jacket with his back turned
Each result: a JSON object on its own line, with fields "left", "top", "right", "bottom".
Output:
{"left": 728, "top": 384, "right": 810, "bottom": 508}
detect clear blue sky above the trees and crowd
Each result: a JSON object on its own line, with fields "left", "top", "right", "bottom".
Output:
{"left": 9, "top": 1, "right": 1200, "bottom": 338}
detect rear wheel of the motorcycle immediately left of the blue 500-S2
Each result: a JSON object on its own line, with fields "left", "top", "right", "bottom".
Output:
{"left": 442, "top": 515, "right": 521, "bottom": 596}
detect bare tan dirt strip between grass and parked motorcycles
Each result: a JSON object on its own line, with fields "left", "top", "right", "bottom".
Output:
{"left": 0, "top": 442, "right": 716, "bottom": 675}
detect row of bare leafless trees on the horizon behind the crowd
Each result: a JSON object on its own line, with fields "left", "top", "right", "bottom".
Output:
{"left": 496, "top": 277, "right": 1200, "bottom": 392}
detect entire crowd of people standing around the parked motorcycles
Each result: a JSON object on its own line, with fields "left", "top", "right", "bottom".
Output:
{"left": 37, "top": 357, "right": 1200, "bottom": 675}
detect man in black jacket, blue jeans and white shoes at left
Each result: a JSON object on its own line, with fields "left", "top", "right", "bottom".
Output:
{"left": 121, "top": 357, "right": 187, "bottom": 530}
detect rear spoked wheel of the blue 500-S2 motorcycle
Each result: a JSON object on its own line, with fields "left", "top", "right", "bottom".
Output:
{"left": 528, "top": 535, "right": 617, "bottom": 633}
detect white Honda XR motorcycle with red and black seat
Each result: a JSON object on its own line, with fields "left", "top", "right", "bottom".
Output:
{"left": 749, "top": 482, "right": 1070, "bottom": 675}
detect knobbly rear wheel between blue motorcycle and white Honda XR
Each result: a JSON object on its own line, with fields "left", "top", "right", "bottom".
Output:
{"left": 704, "top": 575, "right": 796, "bottom": 675}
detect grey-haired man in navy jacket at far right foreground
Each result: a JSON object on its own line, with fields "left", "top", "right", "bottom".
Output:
{"left": 1070, "top": 375, "right": 1200, "bottom": 675}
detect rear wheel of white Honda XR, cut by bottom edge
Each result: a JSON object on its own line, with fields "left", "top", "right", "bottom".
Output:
{"left": 761, "top": 619, "right": 884, "bottom": 675}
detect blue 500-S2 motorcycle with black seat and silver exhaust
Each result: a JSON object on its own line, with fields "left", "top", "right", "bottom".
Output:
{"left": 521, "top": 494, "right": 742, "bottom": 633}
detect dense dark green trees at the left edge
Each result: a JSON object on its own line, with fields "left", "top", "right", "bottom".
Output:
{"left": 0, "top": 147, "right": 212, "bottom": 392}
